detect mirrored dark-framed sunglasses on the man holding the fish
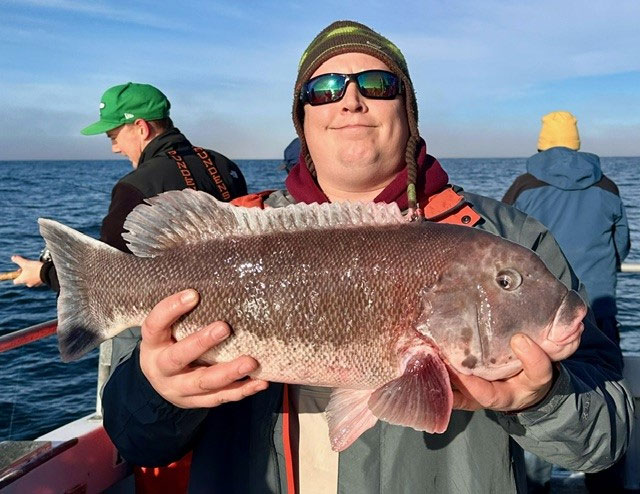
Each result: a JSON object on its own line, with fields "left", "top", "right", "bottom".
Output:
{"left": 300, "top": 70, "right": 402, "bottom": 106}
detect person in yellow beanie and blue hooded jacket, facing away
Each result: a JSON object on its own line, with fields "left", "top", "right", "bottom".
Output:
{"left": 502, "top": 111, "right": 631, "bottom": 494}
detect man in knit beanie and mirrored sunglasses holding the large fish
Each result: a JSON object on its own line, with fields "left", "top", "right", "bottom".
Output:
{"left": 102, "top": 21, "right": 633, "bottom": 494}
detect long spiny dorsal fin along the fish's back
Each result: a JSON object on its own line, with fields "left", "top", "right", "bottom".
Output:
{"left": 122, "top": 189, "right": 405, "bottom": 257}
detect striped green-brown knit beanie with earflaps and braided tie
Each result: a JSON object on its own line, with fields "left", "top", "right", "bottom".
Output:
{"left": 292, "top": 21, "right": 420, "bottom": 206}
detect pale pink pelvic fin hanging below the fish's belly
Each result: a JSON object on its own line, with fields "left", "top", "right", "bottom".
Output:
{"left": 326, "top": 389, "right": 378, "bottom": 451}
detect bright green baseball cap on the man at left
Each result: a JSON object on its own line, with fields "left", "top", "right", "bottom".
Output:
{"left": 80, "top": 82, "right": 171, "bottom": 136}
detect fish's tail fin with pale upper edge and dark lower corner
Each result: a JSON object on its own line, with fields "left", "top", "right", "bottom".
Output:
{"left": 38, "top": 218, "right": 119, "bottom": 362}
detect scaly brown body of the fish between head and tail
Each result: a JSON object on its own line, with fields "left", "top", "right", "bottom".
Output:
{"left": 90, "top": 225, "right": 460, "bottom": 387}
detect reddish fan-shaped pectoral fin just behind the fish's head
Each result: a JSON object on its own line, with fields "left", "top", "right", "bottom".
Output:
{"left": 368, "top": 351, "right": 453, "bottom": 433}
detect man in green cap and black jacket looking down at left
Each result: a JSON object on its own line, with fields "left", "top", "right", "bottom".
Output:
{"left": 11, "top": 82, "right": 247, "bottom": 292}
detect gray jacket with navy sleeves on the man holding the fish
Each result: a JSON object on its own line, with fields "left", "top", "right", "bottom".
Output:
{"left": 103, "top": 189, "right": 633, "bottom": 494}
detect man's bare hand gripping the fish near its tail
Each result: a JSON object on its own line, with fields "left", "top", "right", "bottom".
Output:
{"left": 140, "top": 290, "right": 268, "bottom": 408}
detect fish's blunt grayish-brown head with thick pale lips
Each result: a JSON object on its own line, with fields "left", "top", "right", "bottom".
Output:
{"left": 416, "top": 232, "right": 587, "bottom": 380}
